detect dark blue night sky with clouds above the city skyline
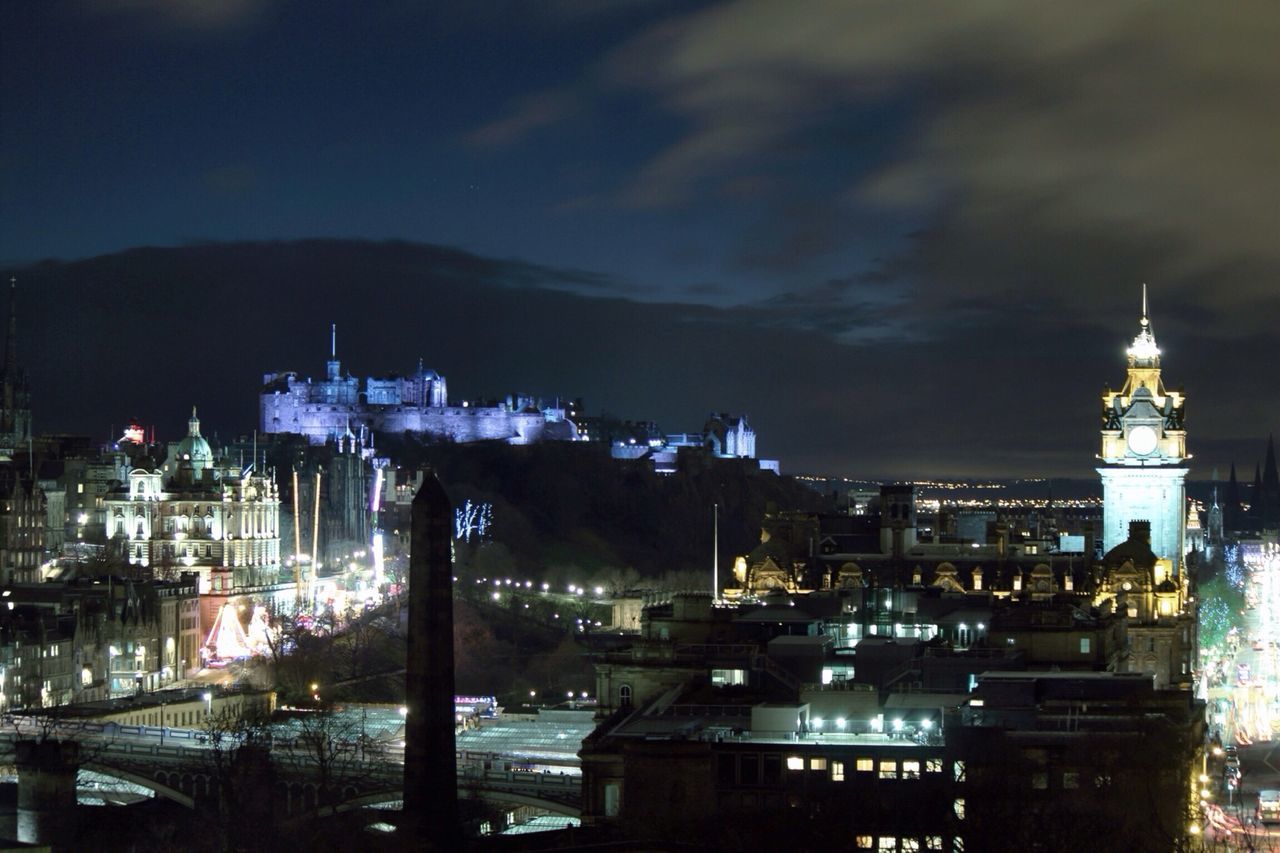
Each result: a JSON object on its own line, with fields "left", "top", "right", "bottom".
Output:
{"left": 0, "top": 0, "right": 1280, "bottom": 479}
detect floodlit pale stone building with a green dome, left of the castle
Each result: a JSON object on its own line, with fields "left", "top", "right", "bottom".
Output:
{"left": 104, "top": 411, "right": 292, "bottom": 624}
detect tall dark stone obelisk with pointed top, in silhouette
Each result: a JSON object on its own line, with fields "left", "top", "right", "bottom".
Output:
{"left": 399, "top": 473, "right": 460, "bottom": 850}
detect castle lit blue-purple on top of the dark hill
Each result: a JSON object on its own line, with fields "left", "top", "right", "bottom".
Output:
{"left": 260, "top": 324, "right": 577, "bottom": 444}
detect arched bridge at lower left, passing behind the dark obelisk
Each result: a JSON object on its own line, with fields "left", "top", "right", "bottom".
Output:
{"left": 0, "top": 722, "right": 582, "bottom": 818}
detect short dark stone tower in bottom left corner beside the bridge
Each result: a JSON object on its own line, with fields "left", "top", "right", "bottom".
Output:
{"left": 13, "top": 740, "right": 79, "bottom": 848}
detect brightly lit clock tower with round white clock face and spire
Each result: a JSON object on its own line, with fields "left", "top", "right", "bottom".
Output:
{"left": 1098, "top": 284, "right": 1190, "bottom": 579}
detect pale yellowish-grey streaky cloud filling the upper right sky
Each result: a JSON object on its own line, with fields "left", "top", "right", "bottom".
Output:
{"left": 478, "top": 0, "right": 1280, "bottom": 334}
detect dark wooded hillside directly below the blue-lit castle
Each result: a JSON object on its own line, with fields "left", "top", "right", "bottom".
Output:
{"left": 380, "top": 437, "right": 822, "bottom": 581}
